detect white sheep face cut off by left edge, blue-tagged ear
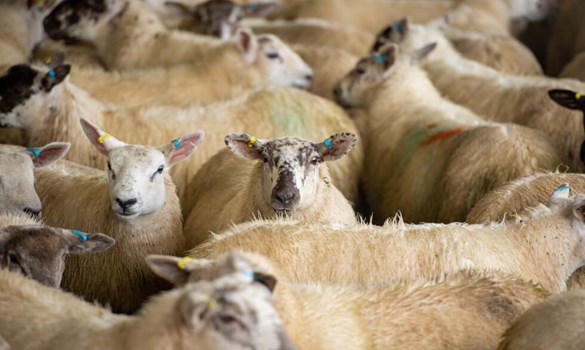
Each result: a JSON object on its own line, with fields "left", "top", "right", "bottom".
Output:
{"left": 0, "top": 142, "right": 70, "bottom": 218}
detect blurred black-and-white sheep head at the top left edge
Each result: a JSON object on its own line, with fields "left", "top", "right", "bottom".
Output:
{"left": 43, "top": 0, "right": 128, "bottom": 42}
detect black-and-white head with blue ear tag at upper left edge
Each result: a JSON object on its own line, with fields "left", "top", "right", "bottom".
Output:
{"left": 0, "top": 64, "right": 71, "bottom": 128}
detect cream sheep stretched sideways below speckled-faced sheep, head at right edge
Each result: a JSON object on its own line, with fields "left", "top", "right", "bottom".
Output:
{"left": 188, "top": 183, "right": 585, "bottom": 293}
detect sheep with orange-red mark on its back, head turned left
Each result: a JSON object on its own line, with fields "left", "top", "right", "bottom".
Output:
{"left": 335, "top": 44, "right": 564, "bottom": 223}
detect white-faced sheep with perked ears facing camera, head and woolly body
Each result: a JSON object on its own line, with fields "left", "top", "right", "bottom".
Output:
{"left": 36, "top": 119, "right": 203, "bottom": 312}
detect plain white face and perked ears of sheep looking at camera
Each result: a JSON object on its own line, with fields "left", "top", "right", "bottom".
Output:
{"left": 81, "top": 119, "right": 203, "bottom": 220}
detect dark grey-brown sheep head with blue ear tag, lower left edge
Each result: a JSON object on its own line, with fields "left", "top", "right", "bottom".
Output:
{"left": 0, "top": 225, "right": 115, "bottom": 288}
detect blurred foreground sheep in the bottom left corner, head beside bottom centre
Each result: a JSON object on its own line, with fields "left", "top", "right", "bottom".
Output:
{"left": 0, "top": 270, "right": 295, "bottom": 350}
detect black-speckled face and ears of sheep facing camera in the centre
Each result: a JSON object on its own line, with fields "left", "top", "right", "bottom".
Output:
{"left": 225, "top": 133, "right": 356, "bottom": 215}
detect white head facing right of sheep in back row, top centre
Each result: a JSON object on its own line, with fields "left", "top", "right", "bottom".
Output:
{"left": 235, "top": 29, "right": 313, "bottom": 90}
